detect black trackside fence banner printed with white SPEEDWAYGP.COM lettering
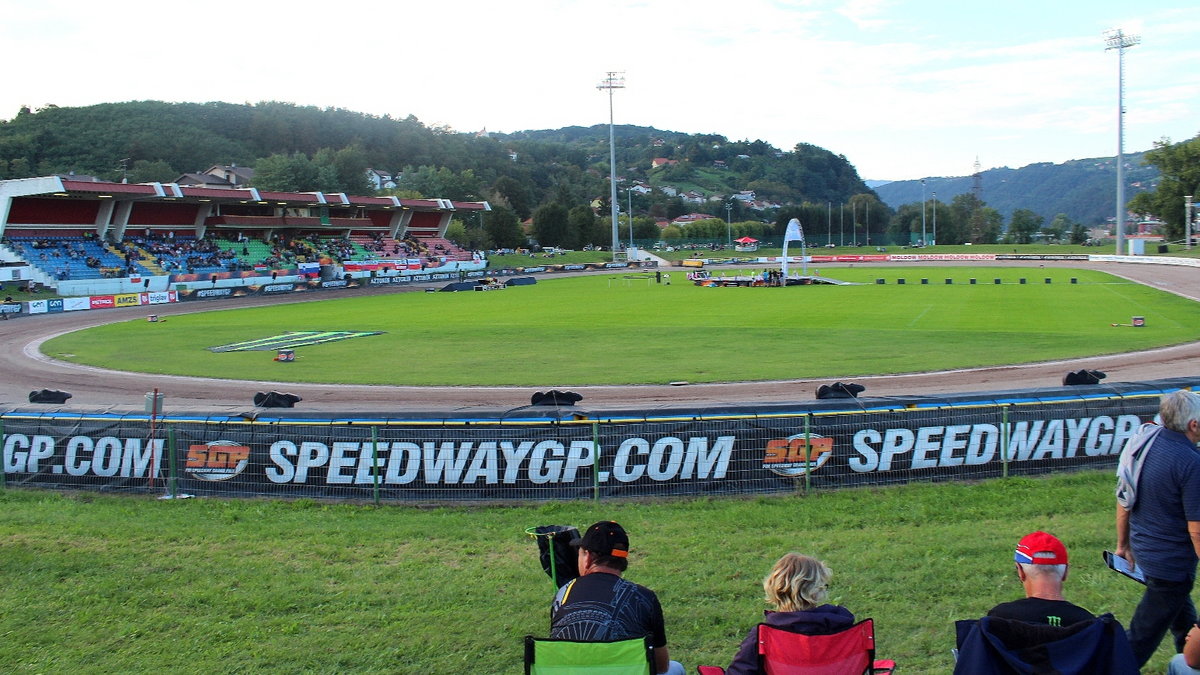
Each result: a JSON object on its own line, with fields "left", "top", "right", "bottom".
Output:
{"left": 0, "top": 378, "right": 1200, "bottom": 502}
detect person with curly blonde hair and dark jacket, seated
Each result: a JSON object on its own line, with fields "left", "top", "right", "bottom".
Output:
{"left": 725, "top": 552, "right": 854, "bottom": 675}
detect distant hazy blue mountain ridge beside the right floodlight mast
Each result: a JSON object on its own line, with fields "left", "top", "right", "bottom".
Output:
{"left": 868, "top": 153, "right": 1159, "bottom": 226}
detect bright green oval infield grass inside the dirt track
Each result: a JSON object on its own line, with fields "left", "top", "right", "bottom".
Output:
{"left": 42, "top": 267, "right": 1200, "bottom": 386}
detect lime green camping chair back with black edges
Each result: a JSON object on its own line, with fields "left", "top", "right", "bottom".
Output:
{"left": 526, "top": 635, "right": 654, "bottom": 675}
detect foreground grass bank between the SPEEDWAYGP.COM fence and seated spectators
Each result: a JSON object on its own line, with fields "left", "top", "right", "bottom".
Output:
{"left": 0, "top": 471, "right": 1169, "bottom": 674}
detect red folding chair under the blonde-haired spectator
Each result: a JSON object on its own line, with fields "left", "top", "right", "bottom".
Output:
{"left": 697, "top": 619, "right": 896, "bottom": 675}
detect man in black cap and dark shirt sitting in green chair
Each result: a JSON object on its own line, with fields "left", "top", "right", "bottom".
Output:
{"left": 550, "top": 520, "right": 684, "bottom": 675}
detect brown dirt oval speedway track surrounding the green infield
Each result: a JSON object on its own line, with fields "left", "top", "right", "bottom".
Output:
{"left": 0, "top": 261, "right": 1200, "bottom": 414}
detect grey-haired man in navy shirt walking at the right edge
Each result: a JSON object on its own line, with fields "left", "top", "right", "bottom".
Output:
{"left": 1115, "top": 390, "right": 1200, "bottom": 667}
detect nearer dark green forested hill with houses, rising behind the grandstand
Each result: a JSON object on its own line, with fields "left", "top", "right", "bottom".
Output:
{"left": 0, "top": 101, "right": 868, "bottom": 219}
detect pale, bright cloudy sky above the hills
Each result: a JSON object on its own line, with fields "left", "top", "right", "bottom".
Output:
{"left": 0, "top": 0, "right": 1200, "bottom": 180}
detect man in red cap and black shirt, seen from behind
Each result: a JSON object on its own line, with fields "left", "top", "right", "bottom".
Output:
{"left": 988, "top": 532, "right": 1096, "bottom": 626}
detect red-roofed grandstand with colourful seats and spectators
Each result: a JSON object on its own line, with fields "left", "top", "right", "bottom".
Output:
{"left": 0, "top": 175, "right": 491, "bottom": 287}
